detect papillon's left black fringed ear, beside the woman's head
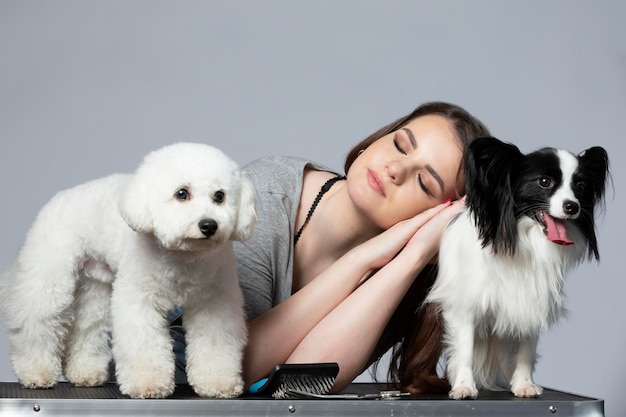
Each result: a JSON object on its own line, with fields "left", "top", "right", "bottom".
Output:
{"left": 464, "top": 137, "right": 523, "bottom": 255}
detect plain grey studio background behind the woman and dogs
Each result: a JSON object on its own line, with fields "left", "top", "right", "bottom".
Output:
{"left": 0, "top": 0, "right": 626, "bottom": 416}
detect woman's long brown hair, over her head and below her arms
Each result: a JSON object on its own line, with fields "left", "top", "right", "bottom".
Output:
{"left": 344, "top": 101, "right": 489, "bottom": 393}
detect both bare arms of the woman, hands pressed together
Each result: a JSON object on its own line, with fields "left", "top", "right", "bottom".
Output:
{"left": 244, "top": 201, "right": 464, "bottom": 388}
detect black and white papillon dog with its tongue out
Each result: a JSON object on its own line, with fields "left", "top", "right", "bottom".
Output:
{"left": 427, "top": 138, "right": 609, "bottom": 399}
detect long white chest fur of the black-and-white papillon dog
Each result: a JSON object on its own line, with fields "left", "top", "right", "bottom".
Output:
{"left": 428, "top": 211, "right": 586, "bottom": 336}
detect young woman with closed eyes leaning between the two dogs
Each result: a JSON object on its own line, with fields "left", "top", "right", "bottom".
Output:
{"left": 235, "top": 102, "right": 489, "bottom": 392}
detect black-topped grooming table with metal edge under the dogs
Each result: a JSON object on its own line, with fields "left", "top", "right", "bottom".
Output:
{"left": 0, "top": 382, "right": 604, "bottom": 417}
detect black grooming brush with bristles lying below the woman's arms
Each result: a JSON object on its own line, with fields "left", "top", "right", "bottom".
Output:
{"left": 249, "top": 362, "right": 339, "bottom": 399}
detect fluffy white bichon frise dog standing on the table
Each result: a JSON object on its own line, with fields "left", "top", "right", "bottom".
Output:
{"left": 0, "top": 143, "right": 256, "bottom": 398}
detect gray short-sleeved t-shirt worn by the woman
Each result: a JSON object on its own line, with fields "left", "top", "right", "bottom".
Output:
{"left": 234, "top": 156, "right": 334, "bottom": 319}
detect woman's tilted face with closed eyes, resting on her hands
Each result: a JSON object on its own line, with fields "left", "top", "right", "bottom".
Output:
{"left": 347, "top": 115, "right": 463, "bottom": 229}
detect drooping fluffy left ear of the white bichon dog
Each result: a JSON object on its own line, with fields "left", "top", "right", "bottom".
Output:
{"left": 118, "top": 174, "right": 153, "bottom": 233}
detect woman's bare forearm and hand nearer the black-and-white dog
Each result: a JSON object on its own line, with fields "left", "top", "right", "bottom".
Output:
{"left": 288, "top": 200, "right": 459, "bottom": 390}
